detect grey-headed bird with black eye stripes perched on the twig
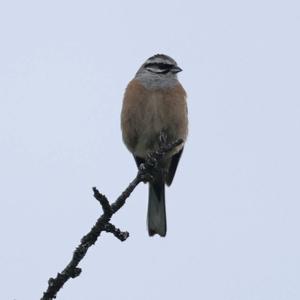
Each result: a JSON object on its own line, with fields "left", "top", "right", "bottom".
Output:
{"left": 121, "top": 54, "right": 188, "bottom": 237}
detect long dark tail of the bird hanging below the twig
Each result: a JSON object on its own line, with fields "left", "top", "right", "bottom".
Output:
{"left": 147, "top": 176, "right": 167, "bottom": 236}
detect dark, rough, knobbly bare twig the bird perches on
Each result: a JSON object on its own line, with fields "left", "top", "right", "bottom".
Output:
{"left": 41, "top": 137, "right": 183, "bottom": 300}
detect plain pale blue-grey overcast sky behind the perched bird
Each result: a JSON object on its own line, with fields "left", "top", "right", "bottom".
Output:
{"left": 0, "top": 0, "right": 300, "bottom": 300}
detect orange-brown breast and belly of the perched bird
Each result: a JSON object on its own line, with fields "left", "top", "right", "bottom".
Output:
{"left": 121, "top": 79, "right": 188, "bottom": 157}
